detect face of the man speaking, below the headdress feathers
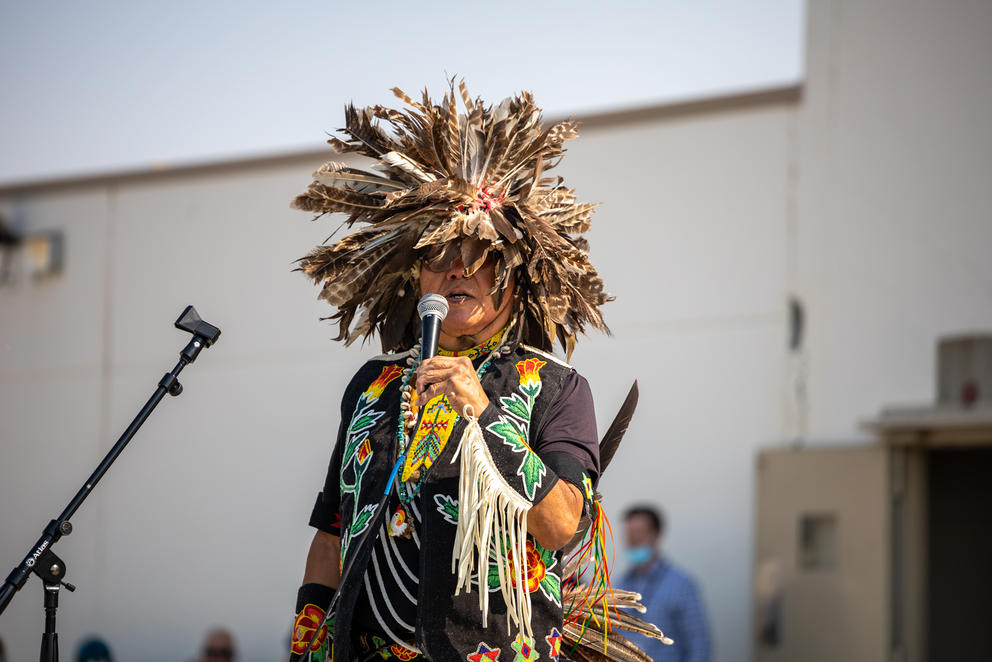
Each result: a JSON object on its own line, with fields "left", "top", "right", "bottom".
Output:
{"left": 420, "top": 256, "right": 512, "bottom": 344}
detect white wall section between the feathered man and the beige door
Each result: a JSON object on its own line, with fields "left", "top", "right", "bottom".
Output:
{"left": 566, "top": 106, "right": 793, "bottom": 662}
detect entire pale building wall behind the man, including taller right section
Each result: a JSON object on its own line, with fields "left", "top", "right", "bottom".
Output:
{"left": 0, "top": 0, "right": 992, "bottom": 662}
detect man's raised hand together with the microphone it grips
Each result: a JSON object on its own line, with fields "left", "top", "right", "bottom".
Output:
{"left": 416, "top": 294, "right": 489, "bottom": 416}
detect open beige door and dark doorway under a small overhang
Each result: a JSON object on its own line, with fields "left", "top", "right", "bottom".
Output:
{"left": 754, "top": 384, "right": 992, "bottom": 662}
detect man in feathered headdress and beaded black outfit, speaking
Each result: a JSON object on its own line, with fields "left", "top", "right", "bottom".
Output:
{"left": 292, "top": 84, "right": 668, "bottom": 662}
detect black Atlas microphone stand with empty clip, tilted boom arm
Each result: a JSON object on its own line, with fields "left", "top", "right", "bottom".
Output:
{"left": 0, "top": 306, "right": 220, "bottom": 662}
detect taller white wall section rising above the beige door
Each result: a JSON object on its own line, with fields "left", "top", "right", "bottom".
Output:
{"left": 792, "top": 0, "right": 992, "bottom": 440}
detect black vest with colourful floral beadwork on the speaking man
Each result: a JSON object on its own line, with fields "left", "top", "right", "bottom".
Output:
{"left": 331, "top": 343, "right": 572, "bottom": 662}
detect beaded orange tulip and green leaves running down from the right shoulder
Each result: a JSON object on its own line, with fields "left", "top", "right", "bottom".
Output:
{"left": 486, "top": 358, "right": 547, "bottom": 499}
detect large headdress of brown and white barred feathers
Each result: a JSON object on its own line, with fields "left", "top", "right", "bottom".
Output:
{"left": 292, "top": 81, "right": 612, "bottom": 354}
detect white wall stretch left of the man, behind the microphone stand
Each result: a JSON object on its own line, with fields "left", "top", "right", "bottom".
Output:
{"left": 0, "top": 166, "right": 362, "bottom": 660}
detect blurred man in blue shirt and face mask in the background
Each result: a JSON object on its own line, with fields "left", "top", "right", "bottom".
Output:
{"left": 615, "top": 506, "right": 711, "bottom": 662}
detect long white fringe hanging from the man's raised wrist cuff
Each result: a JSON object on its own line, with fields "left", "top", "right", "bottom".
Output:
{"left": 451, "top": 405, "right": 534, "bottom": 637}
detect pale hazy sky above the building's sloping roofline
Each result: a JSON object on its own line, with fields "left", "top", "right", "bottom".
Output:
{"left": 0, "top": 0, "right": 804, "bottom": 184}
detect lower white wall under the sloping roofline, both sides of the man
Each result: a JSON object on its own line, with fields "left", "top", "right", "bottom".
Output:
{"left": 0, "top": 100, "right": 794, "bottom": 660}
